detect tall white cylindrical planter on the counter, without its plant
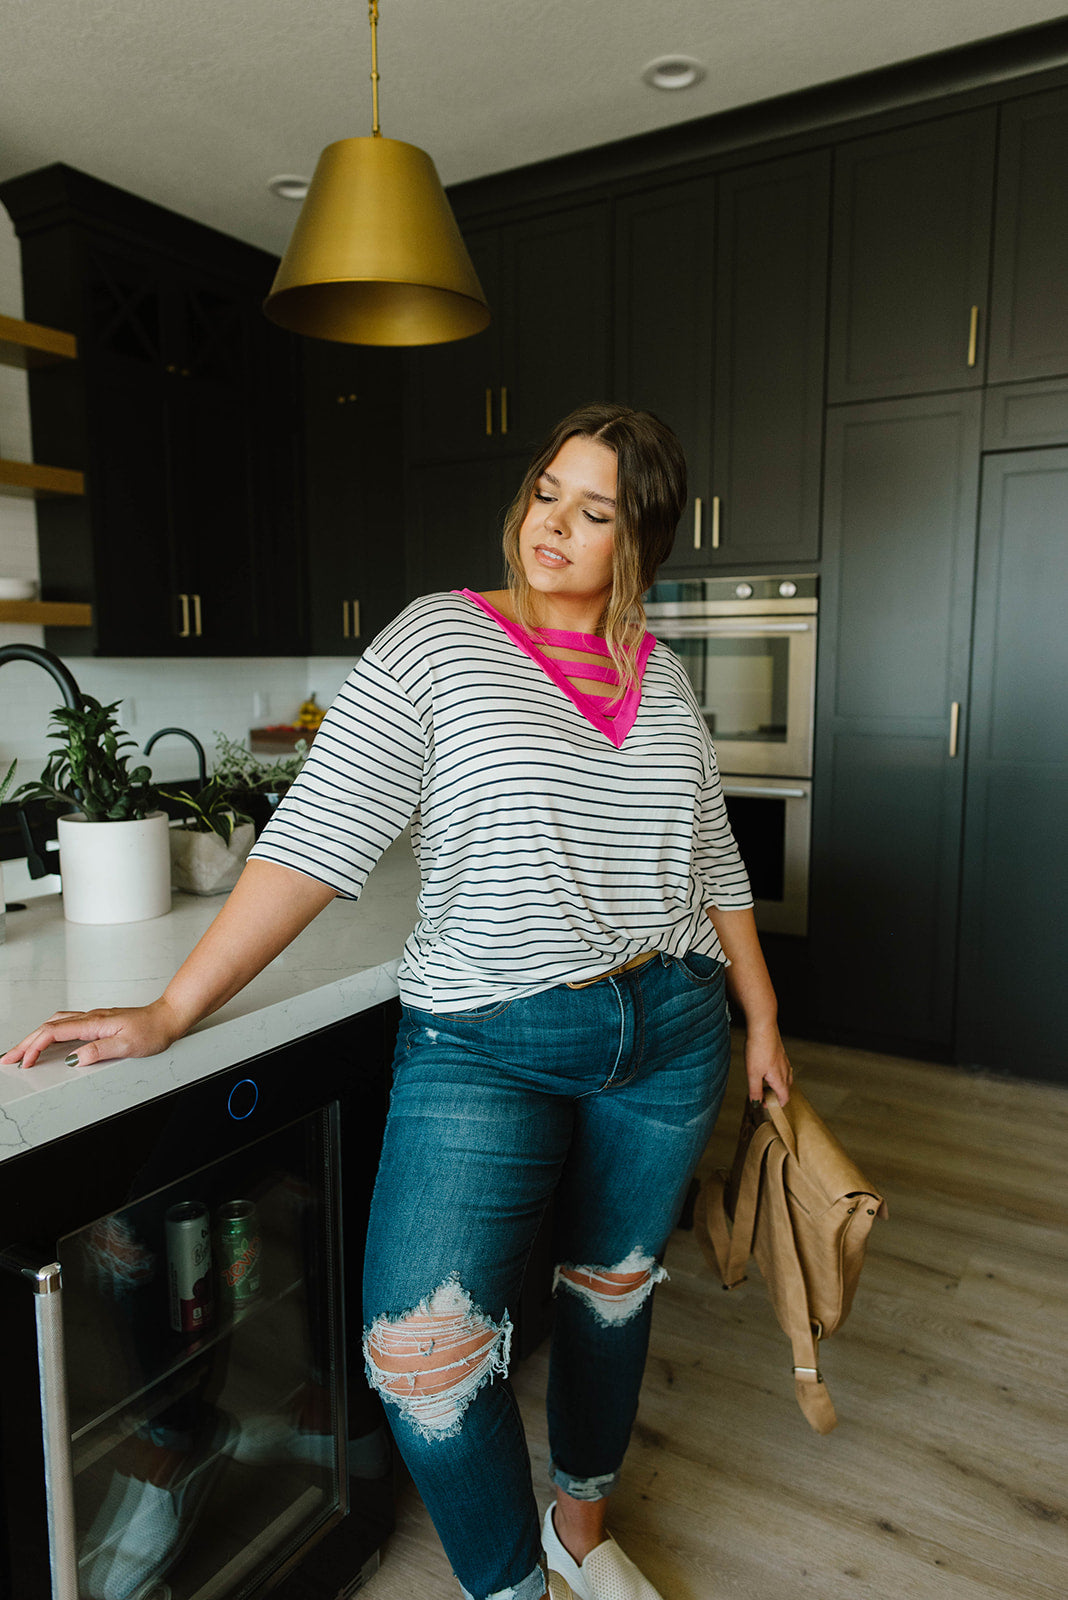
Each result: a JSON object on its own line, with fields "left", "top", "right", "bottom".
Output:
{"left": 59, "top": 811, "right": 171, "bottom": 923}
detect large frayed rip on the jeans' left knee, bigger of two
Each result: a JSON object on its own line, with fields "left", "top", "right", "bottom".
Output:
{"left": 363, "top": 1274, "right": 512, "bottom": 1438}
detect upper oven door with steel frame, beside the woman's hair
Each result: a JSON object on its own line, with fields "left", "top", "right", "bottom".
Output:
{"left": 649, "top": 606, "right": 815, "bottom": 778}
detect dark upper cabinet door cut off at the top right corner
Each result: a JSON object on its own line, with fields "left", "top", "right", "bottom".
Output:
{"left": 990, "top": 90, "right": 1068, "bottom": 384}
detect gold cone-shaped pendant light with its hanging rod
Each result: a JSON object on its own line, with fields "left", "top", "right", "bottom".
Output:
{"left": 264, "top": 0, "right": 489, "bottom": 344}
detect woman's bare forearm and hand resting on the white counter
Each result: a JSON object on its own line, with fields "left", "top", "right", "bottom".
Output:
{"left": 0, "top": 861, "right": 334, "bottom": 1067}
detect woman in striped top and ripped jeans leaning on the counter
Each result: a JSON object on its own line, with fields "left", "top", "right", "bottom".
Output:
{"left": 3, "top": 405, "right": 791, "bottom": 1600}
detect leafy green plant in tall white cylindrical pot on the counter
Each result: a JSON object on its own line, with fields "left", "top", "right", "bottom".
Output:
{"left": 13, "top": 694, "right": 171, "bottom": 923}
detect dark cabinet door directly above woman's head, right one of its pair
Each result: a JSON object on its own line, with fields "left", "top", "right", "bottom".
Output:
{"left": 500, "top": 205, "right": 612, "bottom": 454}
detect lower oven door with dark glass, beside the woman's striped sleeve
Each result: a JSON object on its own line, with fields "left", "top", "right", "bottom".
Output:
{"left": 721, "top": 776, "right": 812, "bottom": 934}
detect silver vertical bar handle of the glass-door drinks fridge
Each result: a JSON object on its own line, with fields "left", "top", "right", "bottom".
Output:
{"left": 0, "top": 1250, "right": 78, "bottom": 1600}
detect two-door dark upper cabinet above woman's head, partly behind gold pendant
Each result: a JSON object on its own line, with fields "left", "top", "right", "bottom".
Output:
{"left": 411, "top": 203, "right": 611, "bottom": 461}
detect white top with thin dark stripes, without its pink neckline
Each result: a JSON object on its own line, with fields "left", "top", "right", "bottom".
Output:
{"left": 253, "top": 594, "right": 753, "bottom": 1011}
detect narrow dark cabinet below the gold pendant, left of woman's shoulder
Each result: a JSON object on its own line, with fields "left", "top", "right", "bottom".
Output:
{"left": 302, "top": 339, "right": 406, "bottom": 656}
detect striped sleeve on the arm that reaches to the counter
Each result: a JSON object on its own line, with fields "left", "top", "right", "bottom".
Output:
{"left": 251, "top": 650, "right": 427, "bottom": 899}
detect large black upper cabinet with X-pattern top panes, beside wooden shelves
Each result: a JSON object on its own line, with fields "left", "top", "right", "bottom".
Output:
{"left": 0, "top": 166, "right": 305, "bottom": 656}
